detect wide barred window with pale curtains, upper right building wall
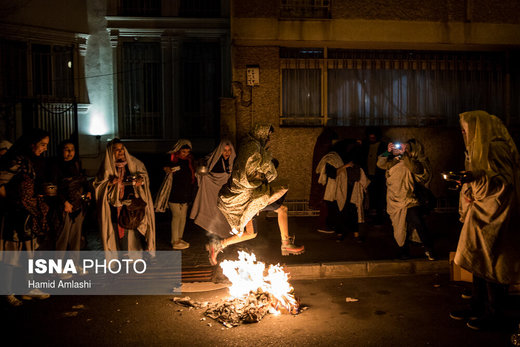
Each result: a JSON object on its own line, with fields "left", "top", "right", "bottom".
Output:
{"left": 280, "top": 49, "right": 508, "bottom": 126}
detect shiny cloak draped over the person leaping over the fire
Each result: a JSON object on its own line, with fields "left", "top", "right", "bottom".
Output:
{"left": 218, "top": 123, "right": 288, "bottom": 232}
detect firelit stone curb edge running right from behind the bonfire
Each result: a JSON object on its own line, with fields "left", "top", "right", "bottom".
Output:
{"left": 285, "top": 259, "right": 450, "bottom": 280}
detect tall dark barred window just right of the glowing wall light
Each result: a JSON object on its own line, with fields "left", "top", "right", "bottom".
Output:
{"left": 119, "top": 43, "right": 163, "bottom": 138}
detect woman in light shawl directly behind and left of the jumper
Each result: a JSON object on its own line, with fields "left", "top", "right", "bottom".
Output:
{"left": 190, "top": 140, "right": 236, "bottom": 238}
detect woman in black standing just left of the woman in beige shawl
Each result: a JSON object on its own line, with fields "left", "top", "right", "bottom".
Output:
{"left": 53, "top": 140, "right": 91, "bottom": 251}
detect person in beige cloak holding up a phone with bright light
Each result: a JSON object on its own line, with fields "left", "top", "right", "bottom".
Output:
{"left": 377, "top": 139, "right": 435, "bottom": 260}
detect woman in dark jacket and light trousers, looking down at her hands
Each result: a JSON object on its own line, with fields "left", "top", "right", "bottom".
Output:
{"left": 155, "top": 139, "right": 196, "bottom": 249}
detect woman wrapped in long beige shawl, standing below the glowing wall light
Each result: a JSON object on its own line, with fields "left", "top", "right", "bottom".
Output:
{"left": 93, "top": 138, "right": 155, "bottom": 252}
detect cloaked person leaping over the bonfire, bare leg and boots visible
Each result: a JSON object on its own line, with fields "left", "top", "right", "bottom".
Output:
{"left": 206, "top": 123, "right": 305, "bottom": 265}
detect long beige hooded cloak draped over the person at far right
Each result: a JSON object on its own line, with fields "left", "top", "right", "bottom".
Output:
{"left": 455, "top": 111, "right": 520, "bottom": 284}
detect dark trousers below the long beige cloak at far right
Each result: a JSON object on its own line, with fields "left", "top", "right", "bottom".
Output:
{"left": 471, "top": 275, "right": 509, "bottom": 317}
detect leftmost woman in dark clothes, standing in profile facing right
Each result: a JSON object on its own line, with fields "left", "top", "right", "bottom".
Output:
{"left": 0, "top": 129, "right": 49, "bottom": 306}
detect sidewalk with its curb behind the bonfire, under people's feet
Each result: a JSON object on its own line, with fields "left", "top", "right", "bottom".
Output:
{"left": 144, "top": 213, "right": 460, "bottom": 280}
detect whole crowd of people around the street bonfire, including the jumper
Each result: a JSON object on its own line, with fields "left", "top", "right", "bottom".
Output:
{"left": 0, "top": 111, "right": 520, "bottom": 329}
